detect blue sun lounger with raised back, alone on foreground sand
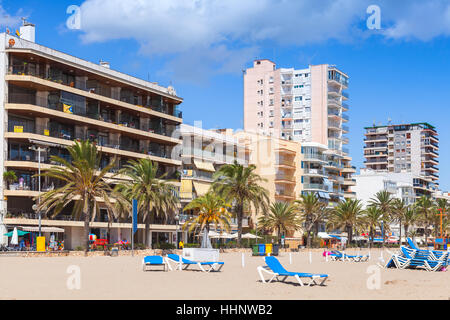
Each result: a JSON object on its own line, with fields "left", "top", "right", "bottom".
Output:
{"left": 257, "top": 256, "right": 328, "bottom": 287}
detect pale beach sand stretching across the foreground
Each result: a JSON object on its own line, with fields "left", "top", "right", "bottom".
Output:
{"left": 0, "top": 250, "right": 450, "bottom": 300}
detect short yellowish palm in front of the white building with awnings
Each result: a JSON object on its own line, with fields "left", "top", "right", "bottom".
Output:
{"left": 183, "top": 192, "right": 231, "bottom": 239}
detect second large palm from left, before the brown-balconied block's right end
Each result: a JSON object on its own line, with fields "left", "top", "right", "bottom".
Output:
{"left": 116, "top": 159, "right": 179, "bottom": 245}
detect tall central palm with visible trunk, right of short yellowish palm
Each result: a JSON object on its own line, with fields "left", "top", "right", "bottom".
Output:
{"left": 212, "top": 161, "right": 269, "bottom": 246}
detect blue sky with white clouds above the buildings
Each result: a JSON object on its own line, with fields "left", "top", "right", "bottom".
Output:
{"left": 0, "top": 0, "right": 450, "bottom": 190}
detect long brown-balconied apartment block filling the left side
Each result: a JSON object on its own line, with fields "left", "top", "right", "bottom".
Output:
{"left": 0, "top": 24, "right": 183, "bottom": 249}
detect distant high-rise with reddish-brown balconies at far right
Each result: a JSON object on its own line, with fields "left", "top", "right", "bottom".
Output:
{"left": 364, "top": 123, "right": 439, "bottom": 197}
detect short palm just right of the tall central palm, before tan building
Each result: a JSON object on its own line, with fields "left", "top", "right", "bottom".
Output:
{"left": 258, "top": 202, "right": 301, "bottom": 242}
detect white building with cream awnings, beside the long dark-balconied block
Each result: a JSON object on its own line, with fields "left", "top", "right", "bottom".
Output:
{"left": 179, "top": 124, "right": 248, "bottom": 237}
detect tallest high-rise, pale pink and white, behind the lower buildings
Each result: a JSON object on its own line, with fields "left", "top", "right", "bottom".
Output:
{"left": 244, "top": 60, "right": 349, "bottom": 154}
